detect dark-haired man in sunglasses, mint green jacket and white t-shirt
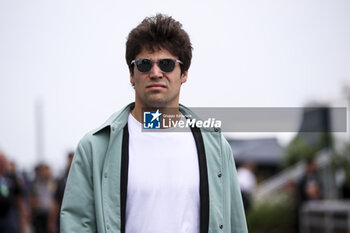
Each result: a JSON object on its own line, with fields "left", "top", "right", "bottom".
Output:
{"left": 61, "top": 14, "right": 247, "bottom": 233}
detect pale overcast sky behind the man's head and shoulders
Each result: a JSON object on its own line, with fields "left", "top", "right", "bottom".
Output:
{"left": 0, "top": 0, "right": 350, "bottom": 173}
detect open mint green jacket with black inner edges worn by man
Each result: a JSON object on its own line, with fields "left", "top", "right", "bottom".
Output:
{"left": 60, "top": 104, "right": 248, "bottom": 233}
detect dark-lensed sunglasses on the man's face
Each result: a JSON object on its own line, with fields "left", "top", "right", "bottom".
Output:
{"left": 131, "top": 58, "right": 183, "bottom": 73}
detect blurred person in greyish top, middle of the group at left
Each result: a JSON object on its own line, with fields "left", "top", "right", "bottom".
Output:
{"left": 30, "top": 164, "right": 56, "bottom": 233}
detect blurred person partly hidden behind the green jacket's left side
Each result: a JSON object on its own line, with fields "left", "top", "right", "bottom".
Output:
{"left": 48, "top": 152, "right": 74, "bottom": 233}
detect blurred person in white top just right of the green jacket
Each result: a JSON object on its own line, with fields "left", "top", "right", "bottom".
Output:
{"left": 237, "top": 163, "right": 256, "bottom": 212}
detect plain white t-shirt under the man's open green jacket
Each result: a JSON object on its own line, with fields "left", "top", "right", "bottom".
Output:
{"left": 125, "top": 114, "right": 200, "bottom": 233}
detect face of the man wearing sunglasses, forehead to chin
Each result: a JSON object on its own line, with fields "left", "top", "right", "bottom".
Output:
{"left": 130, "top": 49, "right": 187, "bottom": 108}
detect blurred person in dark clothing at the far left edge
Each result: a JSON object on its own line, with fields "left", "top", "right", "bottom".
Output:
{"left": 0, "top": 152, "right": 24, "bottom": 233}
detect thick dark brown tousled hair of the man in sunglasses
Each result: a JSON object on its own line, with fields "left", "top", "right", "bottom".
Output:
{"left": 125, "top": 14, "right": 192, "bottom": 74}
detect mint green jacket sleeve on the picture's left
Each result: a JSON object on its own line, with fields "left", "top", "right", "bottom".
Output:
{"left": 60, "top": 142, "right": 97, "bottom": 233}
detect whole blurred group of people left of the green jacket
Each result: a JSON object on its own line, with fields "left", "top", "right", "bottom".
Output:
{"left": 0, "top": 152, "right": 74, "bottom": 233}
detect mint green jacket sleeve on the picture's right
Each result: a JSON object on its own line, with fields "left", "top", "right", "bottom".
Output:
{"left": 222, "top": 137, "right": 248, "bottom": 233}
